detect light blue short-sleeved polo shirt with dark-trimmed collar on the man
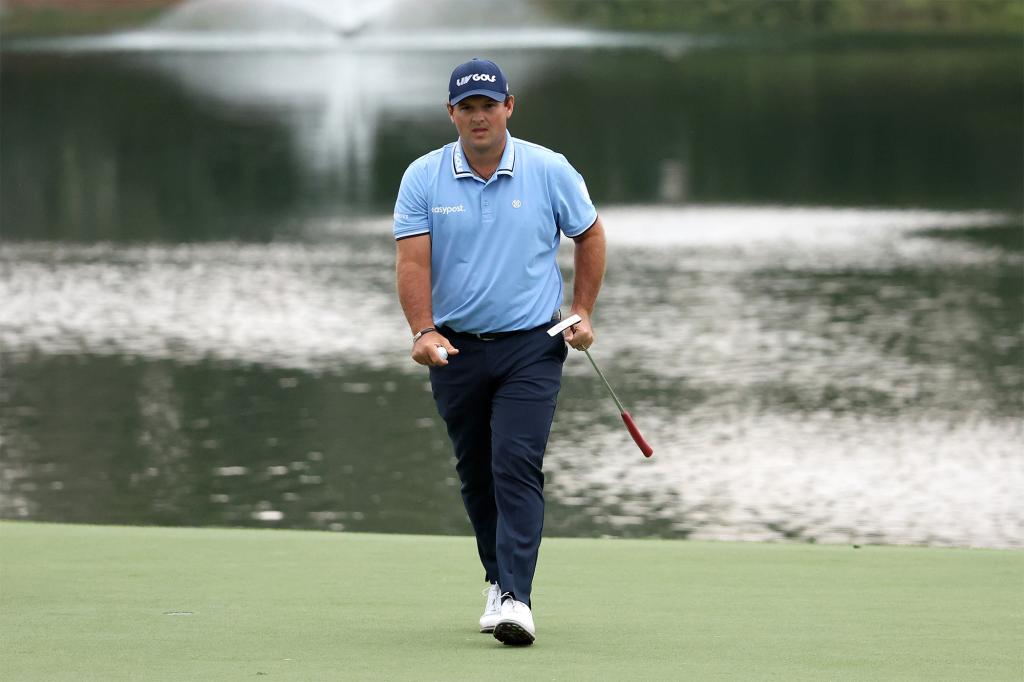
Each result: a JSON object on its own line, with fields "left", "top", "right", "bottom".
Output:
{"left": 394, "top": 133, "right": 597, "bottom": 333}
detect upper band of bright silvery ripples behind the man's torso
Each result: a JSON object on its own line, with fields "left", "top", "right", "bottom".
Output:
{"left": 0, "top": 207, "right": 1020, "bottom": 374}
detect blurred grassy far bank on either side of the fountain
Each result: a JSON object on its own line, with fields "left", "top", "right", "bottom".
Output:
{"left": 0, "top": 0, "right": 1024, "bottom": 40}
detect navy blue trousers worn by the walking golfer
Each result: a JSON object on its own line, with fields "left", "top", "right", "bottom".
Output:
{"left": 430, "top": 322, "right": 568, "bottom": 604}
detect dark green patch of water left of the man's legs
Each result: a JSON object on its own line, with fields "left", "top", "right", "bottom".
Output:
{"left": 2, "top": 356, "right": 465, "bottom": 532}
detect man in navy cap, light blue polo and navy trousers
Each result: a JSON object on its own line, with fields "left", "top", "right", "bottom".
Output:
{"left": 394, "top": 58, "right": 605, "bottom": 644}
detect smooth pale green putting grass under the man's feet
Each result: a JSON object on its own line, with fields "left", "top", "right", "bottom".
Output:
{"left": 0, "top": 522, "right": 1024, "bottom": 681}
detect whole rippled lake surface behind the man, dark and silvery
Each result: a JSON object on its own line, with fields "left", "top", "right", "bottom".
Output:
{"left": 0, "top": 15, "right": 1024, "bottom": 547}
